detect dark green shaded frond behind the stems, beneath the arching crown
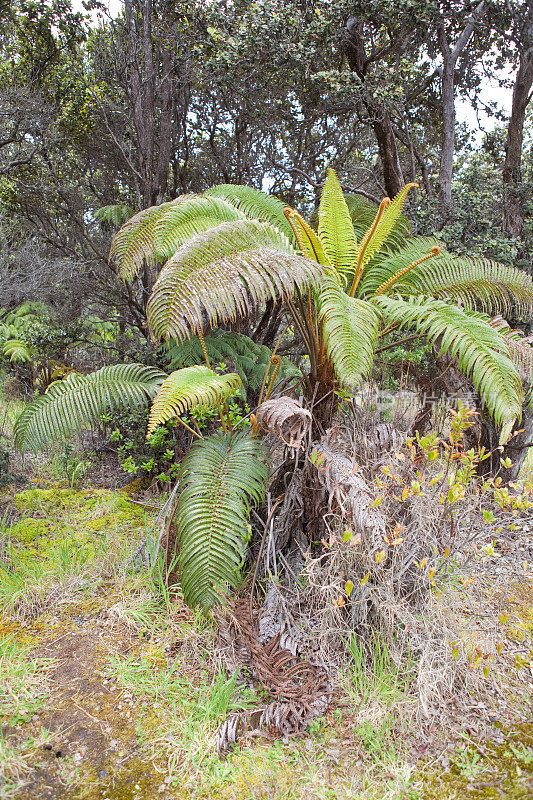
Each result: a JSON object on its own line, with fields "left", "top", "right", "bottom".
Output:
{"left": 163, "top": 330, "right": 302, "bottom": 391}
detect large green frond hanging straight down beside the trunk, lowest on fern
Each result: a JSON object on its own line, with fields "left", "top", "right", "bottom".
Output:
{"left": 176, "top": 432, "right": 268, "bottom": 609}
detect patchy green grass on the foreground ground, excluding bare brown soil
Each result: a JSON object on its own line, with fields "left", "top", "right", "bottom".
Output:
{"left": 0, "top": 488, "right": 533, "bottom": 800}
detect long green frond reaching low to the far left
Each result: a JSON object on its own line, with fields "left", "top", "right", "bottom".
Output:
{"left": 13, "top": 364, "right": 166, "bottom": 451}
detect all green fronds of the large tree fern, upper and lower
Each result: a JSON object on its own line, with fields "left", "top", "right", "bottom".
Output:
{"left": 14, "top": 171, "right": 533, "bottom": 608}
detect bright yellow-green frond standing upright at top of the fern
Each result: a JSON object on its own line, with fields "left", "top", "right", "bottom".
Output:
{"left": 318, "top": 169, "right": 357, "bottom": 273}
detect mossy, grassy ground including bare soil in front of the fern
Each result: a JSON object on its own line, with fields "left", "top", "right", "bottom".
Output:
{"left": 0, "top": 487, "right": 533, "bottom": 800}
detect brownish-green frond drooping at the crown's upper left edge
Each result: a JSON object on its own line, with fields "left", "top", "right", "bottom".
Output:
{"left": 109, "top": 194, "right": 195, "bottom": 281}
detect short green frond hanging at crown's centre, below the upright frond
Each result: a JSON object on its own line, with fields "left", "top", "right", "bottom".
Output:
{"left": 319, "top": 278, "right": 379, "bottom": 386}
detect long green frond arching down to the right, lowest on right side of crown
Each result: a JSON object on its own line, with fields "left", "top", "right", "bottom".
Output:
{"left": 374, "top": 296, "right": 523, "bottom": 432}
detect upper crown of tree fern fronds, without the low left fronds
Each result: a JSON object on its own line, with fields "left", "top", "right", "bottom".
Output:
{"left": 16, "top": 171, "right": 533, "bottom": 444}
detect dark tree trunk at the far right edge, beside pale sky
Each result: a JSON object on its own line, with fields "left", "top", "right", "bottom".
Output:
{"left": 502, "top": 2, "right": 533, "bottom": 239}
